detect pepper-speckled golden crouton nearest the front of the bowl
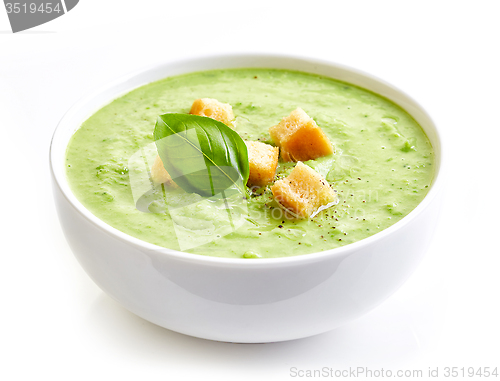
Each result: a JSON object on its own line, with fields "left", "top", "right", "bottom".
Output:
{"left": 271, "top": 161, "right": 337, "bottom": 218}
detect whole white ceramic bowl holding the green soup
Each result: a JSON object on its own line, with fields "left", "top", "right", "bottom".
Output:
{"left": 50, "top": 55, "right": 442, "bottom": 343}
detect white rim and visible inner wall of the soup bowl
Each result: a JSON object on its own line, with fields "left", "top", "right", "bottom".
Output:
{"left": 50, "top": 55, "right": 442, "bottom": 263}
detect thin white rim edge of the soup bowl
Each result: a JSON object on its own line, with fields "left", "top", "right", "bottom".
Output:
{"left": 49, "top": 53, "right": 444, "bottom": 268}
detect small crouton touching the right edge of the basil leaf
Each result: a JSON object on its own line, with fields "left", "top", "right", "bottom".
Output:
{"left": 245, "top": 142, "right": 279, "bottom": 187}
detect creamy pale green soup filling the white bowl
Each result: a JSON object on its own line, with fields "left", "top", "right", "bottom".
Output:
{"left": 66, "top": 69, "right": 434, "bottom": 258}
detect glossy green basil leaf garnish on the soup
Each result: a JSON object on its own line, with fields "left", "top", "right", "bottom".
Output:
{"left": 154, "top": 113, "right": 250, "bottom": 197}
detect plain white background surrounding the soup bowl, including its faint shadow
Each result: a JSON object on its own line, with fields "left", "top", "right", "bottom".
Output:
{"left": 0, "top": 0, "right": 500, "bottom": 380}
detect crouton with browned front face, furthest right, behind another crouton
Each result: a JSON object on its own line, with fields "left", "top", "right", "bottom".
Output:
{"left": 269, "top": 107, "right": 333, "bottom": 161}
